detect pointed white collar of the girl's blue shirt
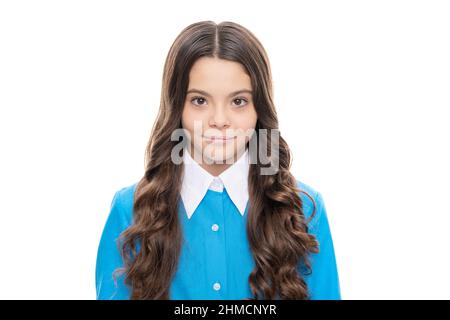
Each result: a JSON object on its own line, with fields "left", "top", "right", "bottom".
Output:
{"left": 181, "top": 148, "right": 250, "bottom": 219}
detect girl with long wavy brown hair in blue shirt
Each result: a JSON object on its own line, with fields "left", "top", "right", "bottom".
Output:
{"left": 96, "top": 21, "right": 340, "bottom": 299}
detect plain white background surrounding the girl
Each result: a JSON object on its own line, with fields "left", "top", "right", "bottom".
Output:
{"left": 0, "top": 0, "right": 450, "bottom": 299}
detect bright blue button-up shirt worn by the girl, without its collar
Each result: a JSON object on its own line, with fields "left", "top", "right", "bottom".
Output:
{"left": 95, "top": 180, "right": 341, "bottom": 300}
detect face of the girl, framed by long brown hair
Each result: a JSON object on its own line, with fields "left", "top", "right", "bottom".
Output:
{"left": 181, "top": 57, "right": 257, "bottom": 168}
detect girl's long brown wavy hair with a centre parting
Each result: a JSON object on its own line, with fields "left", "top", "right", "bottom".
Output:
{"left": 115, "top": 21, "right": 318, "bottom": 300}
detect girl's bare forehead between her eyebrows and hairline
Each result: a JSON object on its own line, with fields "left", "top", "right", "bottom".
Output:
{"left": 185, "top": 57, "right": 252, "bottom": 94}
